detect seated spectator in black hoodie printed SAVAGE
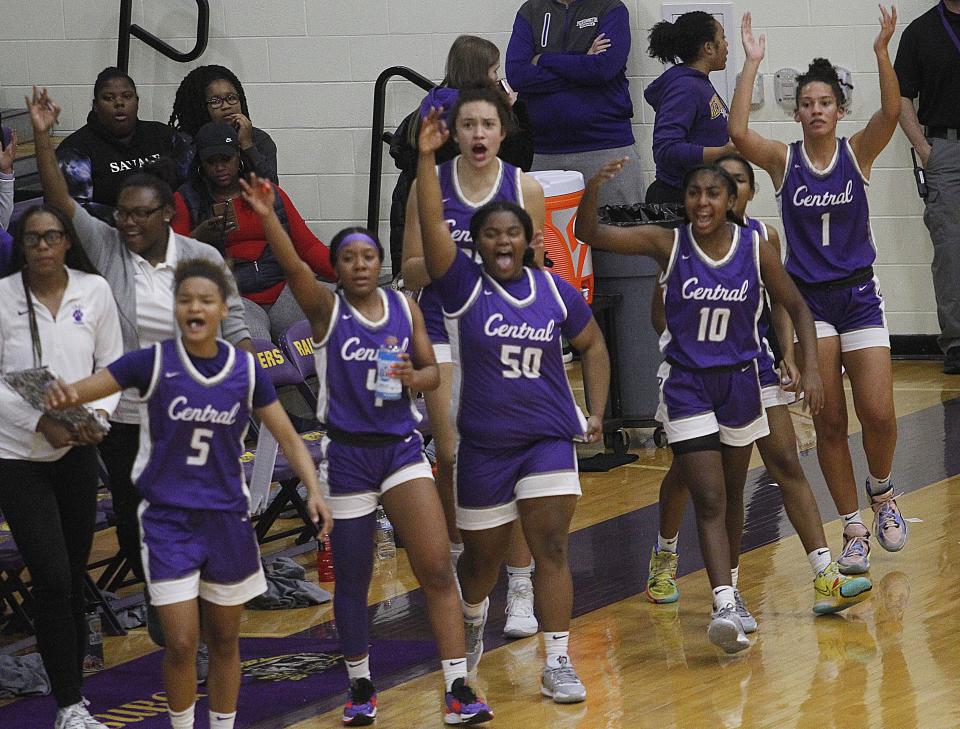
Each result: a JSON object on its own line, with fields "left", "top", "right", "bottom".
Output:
{"left": 57, "top": 66, "right": 184, "bottom": 219}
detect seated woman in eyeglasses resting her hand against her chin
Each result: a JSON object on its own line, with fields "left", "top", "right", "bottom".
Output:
{"left": 170, "top": 65, "right": 279, "bottom": 184}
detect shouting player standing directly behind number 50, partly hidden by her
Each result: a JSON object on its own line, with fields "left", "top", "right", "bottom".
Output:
{"left": 403, "top": 88, "right": 545, "bottom": 638}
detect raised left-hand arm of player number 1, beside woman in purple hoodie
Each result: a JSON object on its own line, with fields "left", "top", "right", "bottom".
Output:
{"left": 727, "top": 13, "right": 787, "bottom": 189}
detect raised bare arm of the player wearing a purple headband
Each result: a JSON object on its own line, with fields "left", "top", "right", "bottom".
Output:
{"left": 240, "top": 174, "right": 334, "bottom": 342}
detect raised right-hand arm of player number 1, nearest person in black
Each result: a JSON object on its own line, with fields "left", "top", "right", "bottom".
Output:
{"left": 850, "top": 5, "right": 902, "bottom": 177}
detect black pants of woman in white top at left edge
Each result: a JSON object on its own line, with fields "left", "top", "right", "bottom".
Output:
{"left": 0, "top": 446, "right": 98, "bottom": 707}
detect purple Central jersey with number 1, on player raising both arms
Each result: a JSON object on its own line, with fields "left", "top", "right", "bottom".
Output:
{"left": 777, "top": 138, "right": 877, "bottom": 284}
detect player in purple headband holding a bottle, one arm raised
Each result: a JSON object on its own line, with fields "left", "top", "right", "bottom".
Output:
{"left": 242, "top": 176, "right": 493, "bottom": 726}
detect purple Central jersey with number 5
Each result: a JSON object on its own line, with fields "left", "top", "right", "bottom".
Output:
{"left": 132, "top": 337, "right": 256, "bottom": 512}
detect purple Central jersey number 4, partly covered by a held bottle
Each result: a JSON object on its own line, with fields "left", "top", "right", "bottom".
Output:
{"left": 313, "top": 289, "right": 420, "bottom": 436}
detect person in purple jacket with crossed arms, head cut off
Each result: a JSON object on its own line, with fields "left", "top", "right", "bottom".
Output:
{"left": 506, "top": 0, "right": 643, "bottom": 205}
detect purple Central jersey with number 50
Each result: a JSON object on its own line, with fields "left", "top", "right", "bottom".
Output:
{"left": 445, "top": 263, "right": 587, "bottom": 447}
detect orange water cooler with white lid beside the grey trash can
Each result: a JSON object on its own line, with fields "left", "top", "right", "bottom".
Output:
{"left": 529, "top": 170, "right": 593, "bottom": 303}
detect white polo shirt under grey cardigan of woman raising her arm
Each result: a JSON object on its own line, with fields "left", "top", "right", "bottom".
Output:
{"left": 111, "top": 229, "right": 179, "bottom": 425}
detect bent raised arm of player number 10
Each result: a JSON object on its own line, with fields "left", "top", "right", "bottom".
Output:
{"left": 574, "top": 157, "right": 673, "bottom": 268}
